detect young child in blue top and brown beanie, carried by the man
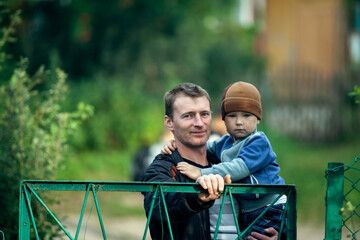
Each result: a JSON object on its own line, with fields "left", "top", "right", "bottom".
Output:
{"left": 162, "top": 82, "right": 286, "bottom": 237}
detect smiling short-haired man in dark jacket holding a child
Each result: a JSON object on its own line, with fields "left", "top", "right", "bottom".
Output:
{"left": 142, "top": 83, "right": 278, "bottom": 240}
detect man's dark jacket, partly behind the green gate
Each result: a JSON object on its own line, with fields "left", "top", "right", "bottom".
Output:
{"left": 142, "top": 150, "right": 219, "bottom": 240}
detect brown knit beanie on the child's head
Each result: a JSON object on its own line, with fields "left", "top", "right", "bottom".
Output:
{"left": 221, "top": 82, "right": 261, "bottom": 120}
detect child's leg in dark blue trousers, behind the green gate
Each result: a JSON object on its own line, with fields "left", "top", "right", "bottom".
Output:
{"left": 240, "top": 204, "right": 286, "bottom": 239}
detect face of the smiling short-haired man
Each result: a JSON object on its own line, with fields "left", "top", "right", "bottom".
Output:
{"left": 164, "top": 95, "right": 212, "bottom": 148}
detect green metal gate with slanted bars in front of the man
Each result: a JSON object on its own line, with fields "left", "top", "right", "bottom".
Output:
{"left": 19, "top": 180, "right": 297, "bottom": 240}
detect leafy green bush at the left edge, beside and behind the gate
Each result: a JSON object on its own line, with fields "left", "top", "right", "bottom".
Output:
{"left": 0, "top": 5, "right": 93, "bottom": 239}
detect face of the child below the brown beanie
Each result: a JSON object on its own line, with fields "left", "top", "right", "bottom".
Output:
{"left": 224, "top": 111, "right": 260, "bottom": 139}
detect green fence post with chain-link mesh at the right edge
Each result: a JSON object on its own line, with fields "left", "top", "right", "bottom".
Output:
{"left": 325, "top": 157, "right": 360, "bottom": 240}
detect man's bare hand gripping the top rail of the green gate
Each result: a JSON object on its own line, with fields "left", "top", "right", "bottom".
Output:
{"left": 196, "top": 174, "right": 231, "bottom": 202}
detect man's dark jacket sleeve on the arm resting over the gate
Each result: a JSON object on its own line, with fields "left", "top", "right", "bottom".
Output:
{"left": 142, "top": 160, "right": 214, "bottom": 223}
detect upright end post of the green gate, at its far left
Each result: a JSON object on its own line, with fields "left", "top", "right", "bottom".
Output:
{"left": 19, "top": 183, "right": 30, "bottom": 240}
